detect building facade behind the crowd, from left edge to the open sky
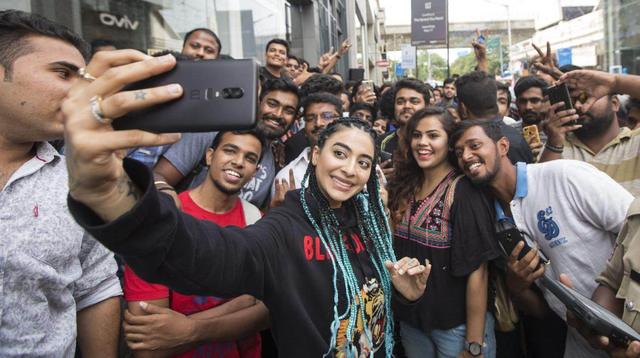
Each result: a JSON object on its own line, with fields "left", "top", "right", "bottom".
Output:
{"left": 0, "top": 0, "right": 380, "bottom": 77}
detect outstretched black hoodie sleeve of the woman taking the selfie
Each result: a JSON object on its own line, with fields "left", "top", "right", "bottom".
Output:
{"left": 68, "top": 159, "right": 284, "bottom": 299}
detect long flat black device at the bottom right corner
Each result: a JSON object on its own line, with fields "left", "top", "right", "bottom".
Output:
{"left": 539, "top": 276, "right": 640, "bottom": 347}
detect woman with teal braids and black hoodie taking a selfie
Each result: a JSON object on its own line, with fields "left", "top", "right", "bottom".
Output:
{"left": 63, "top": 50, "right": 430, "bottom": 357}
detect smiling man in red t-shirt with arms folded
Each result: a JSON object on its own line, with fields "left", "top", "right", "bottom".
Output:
{"left": 124, "top": 131, "right": 269, "bottom": 358}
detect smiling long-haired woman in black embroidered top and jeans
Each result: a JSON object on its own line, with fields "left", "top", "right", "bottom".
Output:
{"left": 389, "top": 108, "right": 500, "bottom": 358}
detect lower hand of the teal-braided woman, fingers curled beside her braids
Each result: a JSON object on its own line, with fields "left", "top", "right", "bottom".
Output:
{"left": 384, "top": 257, "right": 431, "bottom": 301}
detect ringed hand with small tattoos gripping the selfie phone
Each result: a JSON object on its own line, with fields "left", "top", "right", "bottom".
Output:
{"left": 62, "top": 50, "right": 182, "bottom": 221}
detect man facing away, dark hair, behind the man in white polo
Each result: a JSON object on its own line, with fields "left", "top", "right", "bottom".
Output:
{"left": 456, "top": 71, "right": 533, "bottom": 164}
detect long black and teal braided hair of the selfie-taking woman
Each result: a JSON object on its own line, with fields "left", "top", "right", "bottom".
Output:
{"left": 300, "top": 118, "right": 396, "bottom": 357}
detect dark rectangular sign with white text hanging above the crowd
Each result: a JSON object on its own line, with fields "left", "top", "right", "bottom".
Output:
{"left": 411, "top": 0, "right": 448, "bottom": 47}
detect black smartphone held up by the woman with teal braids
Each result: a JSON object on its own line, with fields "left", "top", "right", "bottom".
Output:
{"left": 113, "top": 59, "right": 259, "bottom": 133}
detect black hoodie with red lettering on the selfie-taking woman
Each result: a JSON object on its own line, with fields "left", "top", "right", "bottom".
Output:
{"left": 69, "top": 159, "right": 410, "bottom": 357}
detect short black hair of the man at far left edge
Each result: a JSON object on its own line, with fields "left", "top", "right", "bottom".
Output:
{"left": 0, "top": 10, "right": 90, "bottom": 81}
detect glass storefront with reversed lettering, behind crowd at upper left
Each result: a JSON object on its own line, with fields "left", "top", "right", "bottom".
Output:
{"left": 0, "top": 0, "right": 288, "bottom": 61}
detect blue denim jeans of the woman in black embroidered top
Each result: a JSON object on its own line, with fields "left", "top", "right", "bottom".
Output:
{"left": 400, "top": 312, "right": 496, "bottom": 358}
